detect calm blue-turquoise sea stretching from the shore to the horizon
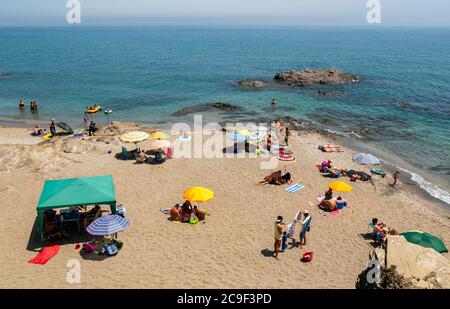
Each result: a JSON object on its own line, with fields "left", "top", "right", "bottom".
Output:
{"left": 0, "top": 27, "right": 450, "bottom": 203}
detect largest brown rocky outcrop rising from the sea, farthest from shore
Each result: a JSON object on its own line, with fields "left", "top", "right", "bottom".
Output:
{"left": 274, "top": 68, "right": 359, "bottom": 86}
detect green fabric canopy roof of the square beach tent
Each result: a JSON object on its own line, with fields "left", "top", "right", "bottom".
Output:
{"left": 37, "top": 176, "right": 116, "bottom": 236}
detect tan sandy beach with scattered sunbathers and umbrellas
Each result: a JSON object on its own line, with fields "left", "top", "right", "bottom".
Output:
{"left": 0, "top": 121, "right": 450, "bottom": 288}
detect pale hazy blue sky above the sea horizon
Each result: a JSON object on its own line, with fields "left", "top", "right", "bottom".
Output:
{"left": 0, "top": 0, "right": 450, "bottom": 27}
